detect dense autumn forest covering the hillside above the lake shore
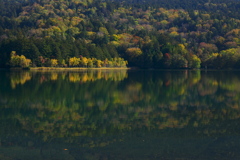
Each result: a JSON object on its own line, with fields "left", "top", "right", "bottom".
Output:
{"left": 0, "top": 0, "right": 240, "bottom": 69}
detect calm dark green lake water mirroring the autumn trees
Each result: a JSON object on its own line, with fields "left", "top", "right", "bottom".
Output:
{"left": 0, "top": 70, "right": 240, "bottom": 160}
